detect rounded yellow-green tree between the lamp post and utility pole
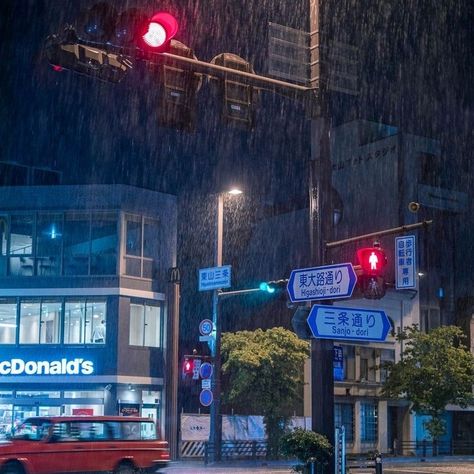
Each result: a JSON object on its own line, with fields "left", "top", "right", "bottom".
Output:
{"left": 221, "top": 327, "right": 309, "bottom": 455}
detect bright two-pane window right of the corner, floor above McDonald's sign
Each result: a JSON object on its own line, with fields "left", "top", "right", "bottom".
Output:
{"left": 129, "top": 303, "right": 162, "bottom": 347}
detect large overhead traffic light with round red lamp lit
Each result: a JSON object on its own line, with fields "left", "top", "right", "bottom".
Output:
{"left": 45, "top": 2, "right": 178, "bottom": 82}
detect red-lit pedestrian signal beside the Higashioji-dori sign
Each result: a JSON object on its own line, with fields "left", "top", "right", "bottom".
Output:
{"left": 357, "top": 244, "right": 387, "bottom": 299}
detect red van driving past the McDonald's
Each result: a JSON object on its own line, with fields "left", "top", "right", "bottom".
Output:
{"left": 0, "top": 416, "right": 169, "bottom": 474}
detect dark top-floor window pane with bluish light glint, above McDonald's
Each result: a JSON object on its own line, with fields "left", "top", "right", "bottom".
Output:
{"left": 36, "top": 213, "right": 63, "bottom": 276}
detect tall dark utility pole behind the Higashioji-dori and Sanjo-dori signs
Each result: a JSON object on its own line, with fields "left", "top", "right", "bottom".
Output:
{"left": 309, "top": 0, "right": 334, "bottom": 473}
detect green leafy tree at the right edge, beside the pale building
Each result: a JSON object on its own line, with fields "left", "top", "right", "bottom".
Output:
{"left": 382, "top": 326, "right": 474, "bottom": 439}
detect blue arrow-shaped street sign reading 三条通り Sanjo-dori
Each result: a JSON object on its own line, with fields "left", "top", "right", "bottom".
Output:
{"left": 308, "top": 305, "right": 391, "bottom": 341}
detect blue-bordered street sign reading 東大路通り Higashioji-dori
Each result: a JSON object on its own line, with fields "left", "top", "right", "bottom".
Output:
{"left": 287, "top": 263, "right": 357, "bottom": 303}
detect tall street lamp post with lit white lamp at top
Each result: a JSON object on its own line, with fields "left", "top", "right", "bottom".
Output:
{"left": 209, "top": 188, "right": 242, "bottom": 462}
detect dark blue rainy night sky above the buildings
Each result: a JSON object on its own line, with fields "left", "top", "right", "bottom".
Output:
{"left": 0, "top": 0, "right": 474, "bottom": 356}
